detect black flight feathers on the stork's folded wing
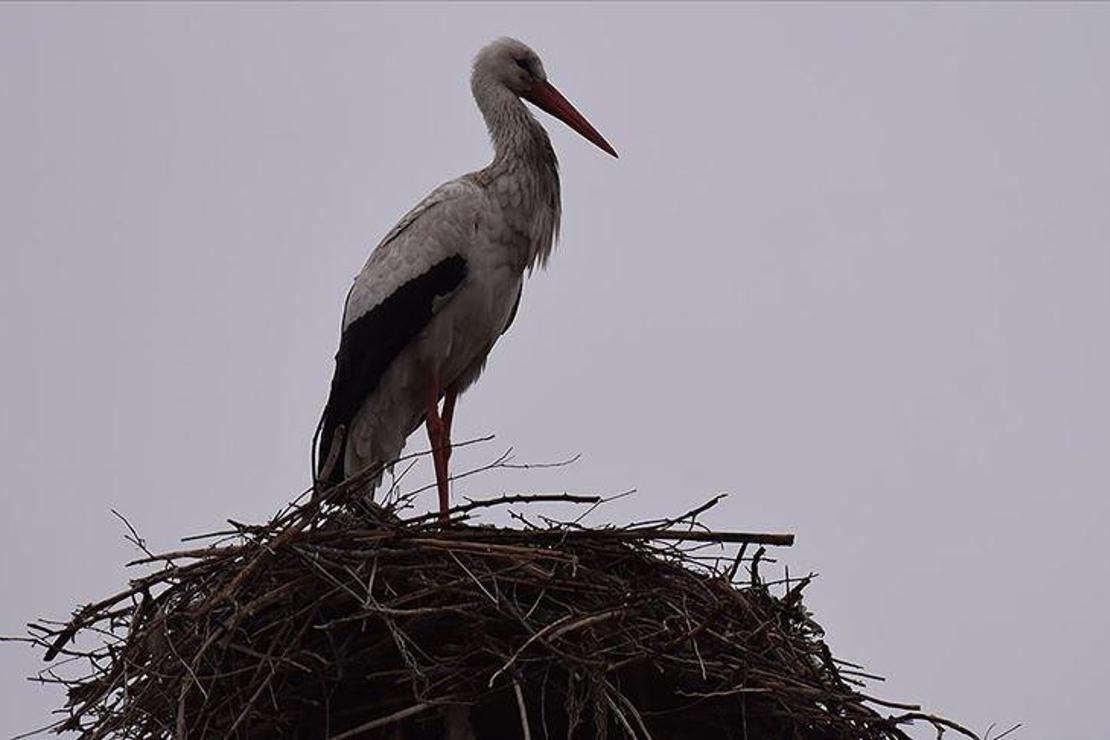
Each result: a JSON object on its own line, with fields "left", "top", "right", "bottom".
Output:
{"left": 316, "top": 254, "right": 466, "bottom": 484}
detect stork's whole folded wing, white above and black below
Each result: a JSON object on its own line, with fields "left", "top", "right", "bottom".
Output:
{"left": 317, "top": 180, "right": 484, "bottom": 483}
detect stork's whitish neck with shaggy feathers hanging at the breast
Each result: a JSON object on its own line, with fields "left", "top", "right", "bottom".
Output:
{"left": 474, "top": 85, "right": 562, "bottom": 267}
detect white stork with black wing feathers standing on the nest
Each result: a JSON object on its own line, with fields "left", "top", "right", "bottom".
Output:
{"left": 315, "top": 38, "right": 617, "bottom": 517}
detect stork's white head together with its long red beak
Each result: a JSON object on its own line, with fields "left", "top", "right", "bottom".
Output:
{"left": 472, "top": 37, "right": 617, "bottom": 156}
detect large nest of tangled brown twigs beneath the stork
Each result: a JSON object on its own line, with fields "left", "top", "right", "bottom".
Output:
{"left": 19, "top": 468, "right": 975, "bottom": 740}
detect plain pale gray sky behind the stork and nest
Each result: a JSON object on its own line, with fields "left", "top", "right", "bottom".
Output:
{"left": 0, "top": 3, "right": 1110, "bottom": 740}
